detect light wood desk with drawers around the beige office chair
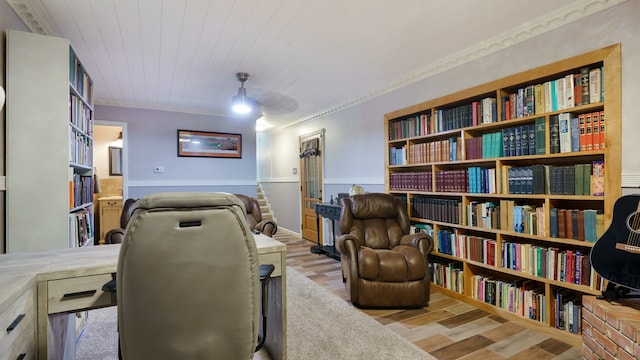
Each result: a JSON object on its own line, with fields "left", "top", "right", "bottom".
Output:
{"left": 0, "top": 235, "right": 287, "bottom": 359}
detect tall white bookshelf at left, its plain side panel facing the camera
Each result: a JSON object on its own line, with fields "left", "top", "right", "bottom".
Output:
{"left": 6, "top": 30, "right": 94, "bottom": 253}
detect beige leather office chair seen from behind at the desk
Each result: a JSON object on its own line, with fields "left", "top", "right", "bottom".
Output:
{"left": 115, "top": 193, "right": 273, "bottom": 360}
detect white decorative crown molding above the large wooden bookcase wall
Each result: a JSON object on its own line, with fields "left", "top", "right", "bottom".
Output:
{"left": 270, "top": 0, "right": 629, "bottom": 134}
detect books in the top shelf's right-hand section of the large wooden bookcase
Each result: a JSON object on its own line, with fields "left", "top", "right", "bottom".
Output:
{"left": 501, "top": 67, "right": 604, "bottom": 120}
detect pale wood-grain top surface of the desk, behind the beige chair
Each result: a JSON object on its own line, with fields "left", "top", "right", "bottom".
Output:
{"left": 0, "top": 234, "right": 287, "bottom": 310}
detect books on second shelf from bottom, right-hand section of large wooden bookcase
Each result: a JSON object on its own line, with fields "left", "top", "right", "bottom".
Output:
{"left": 501, "top": 241, "right": 602, "bottom": 288}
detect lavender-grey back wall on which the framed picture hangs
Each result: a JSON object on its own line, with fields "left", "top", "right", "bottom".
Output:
{"left": 95, "top": 105, "right": 257, "bottom": 198}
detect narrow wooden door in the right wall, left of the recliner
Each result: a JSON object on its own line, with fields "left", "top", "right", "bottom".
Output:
{"left": 300, "top": 132, "right": 322, "bottom": 242}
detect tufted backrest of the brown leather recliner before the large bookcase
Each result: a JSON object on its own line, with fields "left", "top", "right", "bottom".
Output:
{"left": 340, "top": 193, "right": 410, "bottom": 249}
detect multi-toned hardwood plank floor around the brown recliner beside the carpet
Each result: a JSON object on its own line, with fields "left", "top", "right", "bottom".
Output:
{"left": 274, "top": 230, "right": 582, "bottom": 360}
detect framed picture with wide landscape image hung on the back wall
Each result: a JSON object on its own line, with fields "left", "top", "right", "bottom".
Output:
{"left": 178, "top": 130, "right": 242, "bottom": 159}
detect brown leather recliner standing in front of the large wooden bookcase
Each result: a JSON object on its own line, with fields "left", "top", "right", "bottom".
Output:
{"left": 336, "top": 193, "right": 433, "bottom": 308}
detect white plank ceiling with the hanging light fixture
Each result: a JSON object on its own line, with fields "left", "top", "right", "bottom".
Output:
{"left": 6, "top": 0, "right": 621, "bottom": 130}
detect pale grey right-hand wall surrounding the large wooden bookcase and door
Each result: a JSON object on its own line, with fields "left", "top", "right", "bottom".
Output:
{"left": 258, "top": 1, "right": 640, "bottom": 238}
